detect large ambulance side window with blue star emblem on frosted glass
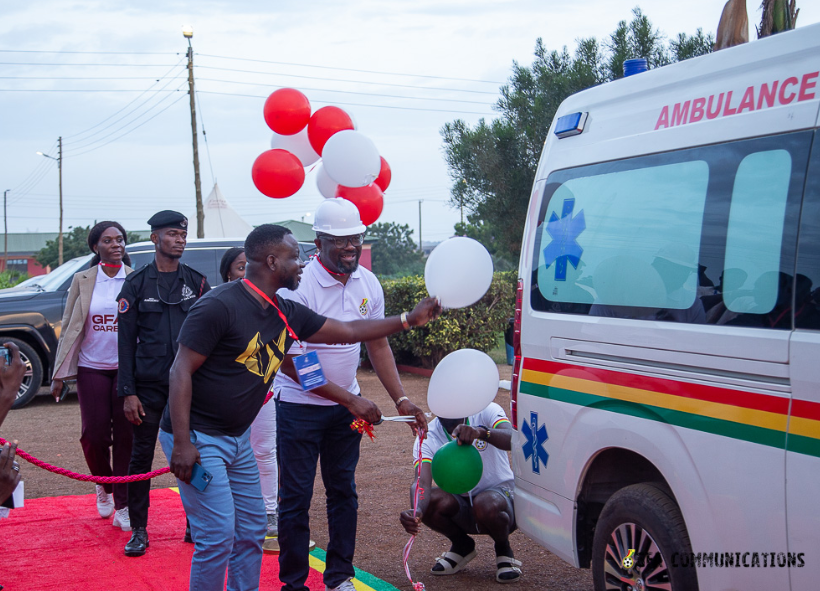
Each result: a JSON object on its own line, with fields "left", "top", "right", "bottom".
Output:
{"left": 530, "top": 132, "right": 811, "bottom": 329}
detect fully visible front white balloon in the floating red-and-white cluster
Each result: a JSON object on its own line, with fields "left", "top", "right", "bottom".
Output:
{"left": 322, "top": 129, "right": 382, "bottom": 187}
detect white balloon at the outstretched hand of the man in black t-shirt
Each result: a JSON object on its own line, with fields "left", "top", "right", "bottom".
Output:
{"left": 424, "top": 236, "right": 493, "bottom": 308}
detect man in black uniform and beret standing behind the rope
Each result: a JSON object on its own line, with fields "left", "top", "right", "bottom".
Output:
{"left": 117, "top": 210, "right": 211, "bottom": 556}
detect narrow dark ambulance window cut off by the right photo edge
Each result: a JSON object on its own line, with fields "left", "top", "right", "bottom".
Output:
{"left": 794, "top": 131, "right": 820, "bottom": 330}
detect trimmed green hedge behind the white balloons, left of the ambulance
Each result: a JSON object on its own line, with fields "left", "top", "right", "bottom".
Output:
{"left": 382, "top": 271, "right": 518, "bottom": 368}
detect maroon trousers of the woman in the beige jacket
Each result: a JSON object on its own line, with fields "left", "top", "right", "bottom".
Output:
{"left": 77, "top": 367, "right": 131, "bottom": 509}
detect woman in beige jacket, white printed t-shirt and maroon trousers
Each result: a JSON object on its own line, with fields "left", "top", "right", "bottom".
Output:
{"left": 51, "top": 222, "right": 132, "bottom": 531}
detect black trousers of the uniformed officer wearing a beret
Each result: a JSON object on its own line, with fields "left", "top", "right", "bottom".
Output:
{"left": 128, "top": 394, "right": 167, "bottom": 529}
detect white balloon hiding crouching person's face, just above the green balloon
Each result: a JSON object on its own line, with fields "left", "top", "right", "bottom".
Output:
{"left": 427, "top": 349, "right": 498, "bottom": 419}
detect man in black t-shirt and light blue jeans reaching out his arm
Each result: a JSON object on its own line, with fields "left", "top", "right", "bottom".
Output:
{"left": 160, "top": 224, "right": 441, "bottom": 591}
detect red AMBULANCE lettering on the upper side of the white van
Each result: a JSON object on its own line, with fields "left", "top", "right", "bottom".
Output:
{"left": 655, "top": 71, "right": 820, "bottom": 130}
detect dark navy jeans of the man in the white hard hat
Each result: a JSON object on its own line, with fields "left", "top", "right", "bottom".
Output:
{"left": 276, "top": 401, "right": 362, "bottom": 591}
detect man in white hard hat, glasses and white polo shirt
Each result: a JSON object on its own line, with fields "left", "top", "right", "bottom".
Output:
{"left": 273, "top": 198, "right": 427, "bottom": 591}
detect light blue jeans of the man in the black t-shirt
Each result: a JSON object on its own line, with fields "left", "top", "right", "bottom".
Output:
{"left": 159, "top": 429, "right": 267, "bottom": 591}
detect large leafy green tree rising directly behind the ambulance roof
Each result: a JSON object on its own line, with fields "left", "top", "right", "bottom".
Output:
{"left": 441, "top": 8, "right": 714, "bottom": 261}
